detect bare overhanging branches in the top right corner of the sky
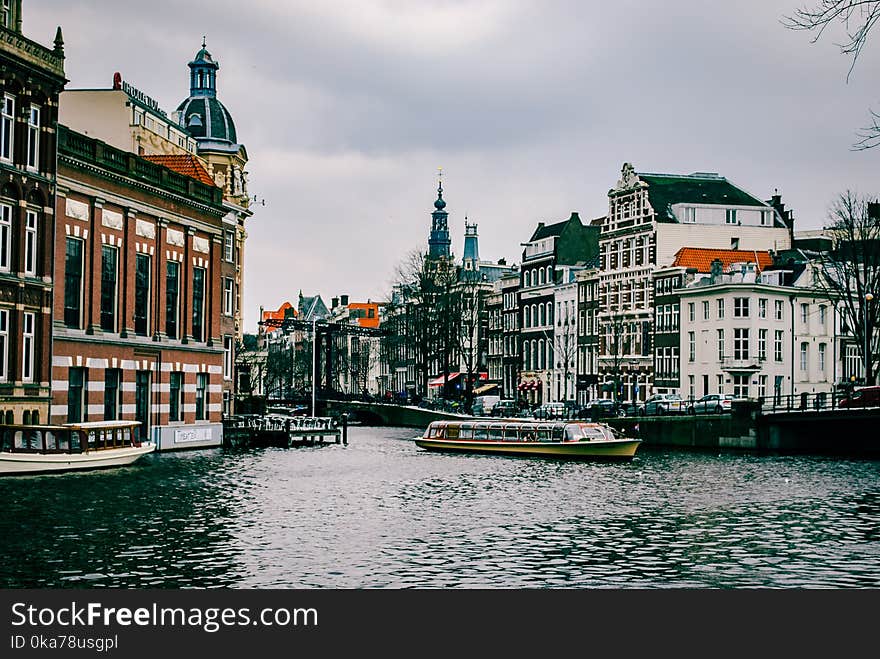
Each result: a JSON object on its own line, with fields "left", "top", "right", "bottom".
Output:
{"left": 782, "top": 0, "right": 880, "bottom": 151}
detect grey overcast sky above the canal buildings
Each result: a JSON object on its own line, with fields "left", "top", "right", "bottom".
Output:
{"left": 23, "top": 0, "right": 880, "bottom": 331}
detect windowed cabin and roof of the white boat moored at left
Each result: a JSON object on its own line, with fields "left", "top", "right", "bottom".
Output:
{"left": 0, "top": 421, "right": 141, "bottom": 454}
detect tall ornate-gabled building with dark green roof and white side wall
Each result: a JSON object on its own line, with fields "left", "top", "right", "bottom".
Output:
{"left": 599, "top": 163, "right": 793, "bottom": 400}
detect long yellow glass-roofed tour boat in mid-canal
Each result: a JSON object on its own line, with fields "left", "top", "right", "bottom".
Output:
{"left": 415, "top": 419, "right": 642, "bottom": 460}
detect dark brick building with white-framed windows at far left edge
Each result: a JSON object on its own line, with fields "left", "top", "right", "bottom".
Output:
{"left": 0, "top": 0, "right": 67, "bottom": 424}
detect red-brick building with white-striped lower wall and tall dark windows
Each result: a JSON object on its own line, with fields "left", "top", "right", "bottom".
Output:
{"left": 51, "top": 125, "right": 226, "bottom": 450}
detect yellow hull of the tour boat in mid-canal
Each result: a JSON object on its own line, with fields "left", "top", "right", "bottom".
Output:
{"left": 415, "top": 437, "right": 641, "bottom": 460}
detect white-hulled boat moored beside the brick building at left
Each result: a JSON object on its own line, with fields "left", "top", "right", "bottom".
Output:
{"left": 0, "top": 421, "right": 156, "bottom": 475}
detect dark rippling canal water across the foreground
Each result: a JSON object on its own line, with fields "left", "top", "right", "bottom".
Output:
{"left": 0, "top": 426, "right": 880, "bottom": 589}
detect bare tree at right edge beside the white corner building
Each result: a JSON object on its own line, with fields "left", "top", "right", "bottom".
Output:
{"left": 814, "top": 191, "right": 880, "bottom": 384}
